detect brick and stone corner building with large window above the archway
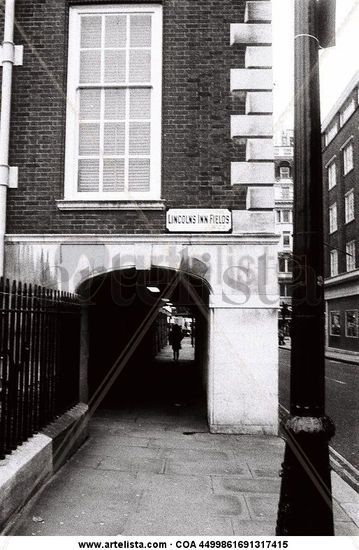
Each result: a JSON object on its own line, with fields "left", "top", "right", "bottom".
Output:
{"left": 0, "top": 0, "right": 278, "bottom": 433}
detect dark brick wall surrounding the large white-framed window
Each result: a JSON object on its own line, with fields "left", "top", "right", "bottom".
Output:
{"left": 7, "top": 0, "right": 246, "bottom": 234}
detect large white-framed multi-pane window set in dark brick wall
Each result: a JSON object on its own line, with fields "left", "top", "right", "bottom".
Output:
{"left": 65, "top": 4, "right": 162, "bottom": 200}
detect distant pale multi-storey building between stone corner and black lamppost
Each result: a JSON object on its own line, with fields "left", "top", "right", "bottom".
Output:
{"left": 274, "top": 130, "right": 294, "bottom": 334}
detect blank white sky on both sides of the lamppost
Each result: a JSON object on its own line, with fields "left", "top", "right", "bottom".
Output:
{"left": 272, "top": 0, "right": 359, "bottom": 141}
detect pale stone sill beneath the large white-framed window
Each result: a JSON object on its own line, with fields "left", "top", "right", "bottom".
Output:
{"left": 56, "top": 200, "right": 166, "bottom": 210}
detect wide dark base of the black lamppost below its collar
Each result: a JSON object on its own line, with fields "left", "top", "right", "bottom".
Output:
{"left": 276, "top": 416, "right": 334, "bottom": 536}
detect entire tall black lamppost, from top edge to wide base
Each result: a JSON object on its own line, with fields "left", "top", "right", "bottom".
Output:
{"left": 277, "top": 0, "right": 334, "bottom": 536}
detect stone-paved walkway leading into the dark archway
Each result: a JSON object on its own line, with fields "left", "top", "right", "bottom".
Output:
{"left": 8, "top": 345, "right": 359, "bottom": 536}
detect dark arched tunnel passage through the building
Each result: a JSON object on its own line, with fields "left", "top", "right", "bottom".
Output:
{"left": 79, "top": 268, "right": 209, "bottom": 411}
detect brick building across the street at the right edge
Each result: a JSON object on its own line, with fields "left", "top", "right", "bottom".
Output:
{"left": 322, "top": 73, "right": 359, "bottom": 357}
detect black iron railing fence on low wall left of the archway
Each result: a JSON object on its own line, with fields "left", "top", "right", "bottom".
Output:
{"left": 0, "top": 278, "right": 81, "bottom": 459}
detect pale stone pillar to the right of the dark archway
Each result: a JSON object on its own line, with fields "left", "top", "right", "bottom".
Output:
{"left": 208, "top": 307, "right": 278, "bottom": 434}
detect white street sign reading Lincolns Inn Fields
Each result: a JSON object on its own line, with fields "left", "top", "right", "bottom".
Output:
{"left": 166, "top": 208, "right": 232, "bottom": 233}
